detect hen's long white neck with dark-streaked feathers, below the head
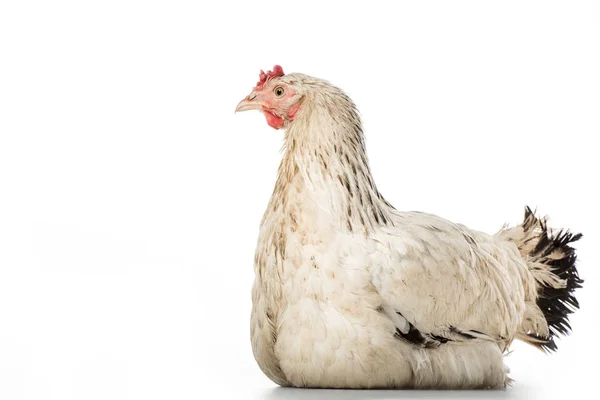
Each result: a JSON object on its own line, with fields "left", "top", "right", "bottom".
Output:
{"left": 271, "top": 88, "right": 393, "bottom": 231}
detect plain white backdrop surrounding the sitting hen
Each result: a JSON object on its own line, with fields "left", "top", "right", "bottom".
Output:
{"left": 0, "top": 0, "right": 600, "bottom": 400}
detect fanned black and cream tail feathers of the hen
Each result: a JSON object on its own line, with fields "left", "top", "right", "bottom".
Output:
{"left": 500, "top": 207, "right": 583, "bottom": 352}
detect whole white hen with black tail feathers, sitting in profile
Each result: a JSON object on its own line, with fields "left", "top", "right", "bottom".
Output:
{"left": 236, "top": 66, "right": 583, "bottom": 389}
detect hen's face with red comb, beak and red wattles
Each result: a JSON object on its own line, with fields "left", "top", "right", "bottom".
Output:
{"left": 235, "top": 65, "right": 302, "bottom": 129}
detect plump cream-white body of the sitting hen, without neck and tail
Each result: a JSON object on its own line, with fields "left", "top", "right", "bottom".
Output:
{"left": 252, "top": 197, "right": 526, "bottom": 388}
